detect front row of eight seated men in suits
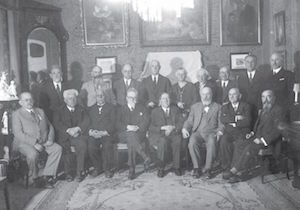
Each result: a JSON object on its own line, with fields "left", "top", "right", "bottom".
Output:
{"left": 12, "top": 83, "right": 283, "bottom": 186}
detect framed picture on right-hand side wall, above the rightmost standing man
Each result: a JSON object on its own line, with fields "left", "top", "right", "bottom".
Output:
{"left": 273, "top": 11, "right": 286, "bottom": 46}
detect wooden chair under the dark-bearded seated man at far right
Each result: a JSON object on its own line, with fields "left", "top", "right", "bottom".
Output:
{"left": 258, "top": 137, "right": 290, "bottom": 184}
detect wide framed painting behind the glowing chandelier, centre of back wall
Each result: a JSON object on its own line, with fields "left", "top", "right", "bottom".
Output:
{"left": 140, "top": 0, "right": 210, "bottom": 46}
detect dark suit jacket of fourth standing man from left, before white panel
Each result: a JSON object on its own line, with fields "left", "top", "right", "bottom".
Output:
{"left": 141, "top": 75, "right": 172, "bottom": 105}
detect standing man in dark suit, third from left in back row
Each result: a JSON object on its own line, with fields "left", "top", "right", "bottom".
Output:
{"left": 113, "top": 64, "right": 140, "bottom": 106}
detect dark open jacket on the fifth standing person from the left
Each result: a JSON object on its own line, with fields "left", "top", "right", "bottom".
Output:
{"left": 171, "top": 82, "right": 198, "bottom": 112}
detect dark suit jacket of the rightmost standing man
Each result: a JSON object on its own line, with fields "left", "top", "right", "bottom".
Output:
{"left": 269, "top": 68, "right": 295, "bottom": 110}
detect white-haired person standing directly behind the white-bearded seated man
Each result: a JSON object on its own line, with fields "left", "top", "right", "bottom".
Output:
{"left": 194, "top": 68, "right": 216, "bottom": 102}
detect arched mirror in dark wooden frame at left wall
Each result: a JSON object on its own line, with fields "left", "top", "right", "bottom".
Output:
{"left": 27, "top": 28, "right": 61, "bottom": 73}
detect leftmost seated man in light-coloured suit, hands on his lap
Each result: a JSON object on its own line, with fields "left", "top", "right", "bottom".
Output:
{"left": 12, "top": 92, "right": 62, "bottom": 187}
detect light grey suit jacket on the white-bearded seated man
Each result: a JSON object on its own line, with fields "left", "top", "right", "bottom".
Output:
{"left": 183, "top": 102, "right": 224, "bottom": 135}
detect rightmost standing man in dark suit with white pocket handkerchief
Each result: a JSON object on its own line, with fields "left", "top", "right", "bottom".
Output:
{"left": 270, "top": 53, "right": 295, "bottom": 116}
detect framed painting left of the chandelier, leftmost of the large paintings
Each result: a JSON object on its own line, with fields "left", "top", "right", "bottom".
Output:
{"left": 82, "top": 0, "right": 129, "bottom": 47}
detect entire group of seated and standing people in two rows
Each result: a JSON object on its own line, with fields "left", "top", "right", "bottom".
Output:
{"left": 13, "top": 50, "right": 293, "bottom": 187}
